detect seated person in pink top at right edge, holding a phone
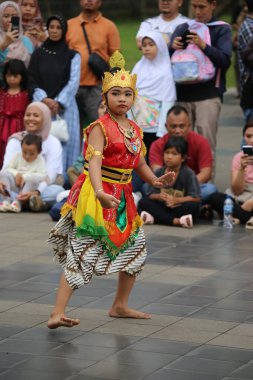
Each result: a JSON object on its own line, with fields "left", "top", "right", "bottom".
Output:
{"left": 209, "top": 118, "right": 253, "bottom": 229}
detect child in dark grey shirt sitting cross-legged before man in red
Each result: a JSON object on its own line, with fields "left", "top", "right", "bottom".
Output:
{"left": 138, "top": 136, "right": 200, "bottom": 228}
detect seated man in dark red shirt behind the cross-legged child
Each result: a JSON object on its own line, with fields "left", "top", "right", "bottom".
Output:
{"left": 149, "top": 106, "right": 217, "bottom": 203}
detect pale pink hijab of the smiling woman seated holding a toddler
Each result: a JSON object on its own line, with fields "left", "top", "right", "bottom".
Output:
{"left": 10, "top": 102, "right": 52, "bottom": 141}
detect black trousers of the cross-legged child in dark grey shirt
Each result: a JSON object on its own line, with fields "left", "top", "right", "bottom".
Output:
{"left": 138, "top": 197, "right": 200, "bottom": 226}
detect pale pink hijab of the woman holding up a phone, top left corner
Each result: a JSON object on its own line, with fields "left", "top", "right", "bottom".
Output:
{"left": 0, "top": 1, "right": 30, "bottom": 66}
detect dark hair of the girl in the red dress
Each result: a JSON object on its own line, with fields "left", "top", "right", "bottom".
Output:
{"left": 3, "top": 59, "right": 28, "bottom": 90}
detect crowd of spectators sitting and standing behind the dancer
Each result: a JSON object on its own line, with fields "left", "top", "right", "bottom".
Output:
{"left": 0, "top": 0, "right": 253, "bottom": 232}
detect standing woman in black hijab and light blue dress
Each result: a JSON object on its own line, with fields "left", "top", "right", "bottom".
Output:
{"left": 28, "top": 15, "right": 81, "bottom": 178}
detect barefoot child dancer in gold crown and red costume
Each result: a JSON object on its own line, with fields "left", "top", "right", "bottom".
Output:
{"left": 48, "top": 52, "right": 173, "bottom": 329}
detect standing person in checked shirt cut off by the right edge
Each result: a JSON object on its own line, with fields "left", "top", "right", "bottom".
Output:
{"left": 238, "top": 0, "right": 253, "bottom": 121}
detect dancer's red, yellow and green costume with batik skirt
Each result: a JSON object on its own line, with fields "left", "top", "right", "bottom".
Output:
{"left": 49, "top": 114, "right": 146, "bottom": 289}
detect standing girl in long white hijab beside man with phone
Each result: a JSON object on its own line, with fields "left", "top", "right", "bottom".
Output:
{"left": 130, "top": 31, "right": 176, "bottom": 152}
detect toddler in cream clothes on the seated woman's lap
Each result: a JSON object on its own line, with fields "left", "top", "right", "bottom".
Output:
{"left": 0, "top": 134, "right": 47, "bottom": 212}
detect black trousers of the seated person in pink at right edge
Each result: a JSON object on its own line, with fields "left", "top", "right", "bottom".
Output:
{"left": 208, "top": 193, "right": 253, "bottom": 224}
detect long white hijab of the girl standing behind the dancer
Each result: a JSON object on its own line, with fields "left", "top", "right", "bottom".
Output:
{"left": 132, "top": 31, "right": 176, "bottom": 102}
